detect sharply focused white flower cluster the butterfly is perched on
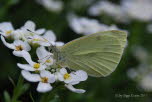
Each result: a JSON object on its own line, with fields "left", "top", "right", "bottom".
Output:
{"left": 0, "top": 21, "right": 88, "bottom": 93}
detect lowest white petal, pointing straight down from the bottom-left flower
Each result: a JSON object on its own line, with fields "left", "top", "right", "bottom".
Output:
{"left": 37, "top": 82, "right": 52, "bottom": 93}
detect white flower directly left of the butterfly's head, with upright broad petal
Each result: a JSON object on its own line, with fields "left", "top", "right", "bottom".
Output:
{"left": 36, "top": 46, "right": 53, "bottom": 66}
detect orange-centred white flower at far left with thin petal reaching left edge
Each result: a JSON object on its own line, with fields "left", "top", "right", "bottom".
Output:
{"left": 1, "top": 36, "right": 31, "bottom": 56}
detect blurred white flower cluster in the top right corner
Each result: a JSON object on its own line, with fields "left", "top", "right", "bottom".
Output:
{"left": 88, "top": 0, "right": 152, "bottom": 23}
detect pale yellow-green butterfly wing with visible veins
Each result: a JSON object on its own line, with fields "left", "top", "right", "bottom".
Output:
{"left": 60, "top": 31, "right": 126, "bottom": 77}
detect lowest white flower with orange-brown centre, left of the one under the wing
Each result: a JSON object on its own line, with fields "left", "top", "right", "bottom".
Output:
{"left": 21, "top": 70, "right": 55, "bottom": 93}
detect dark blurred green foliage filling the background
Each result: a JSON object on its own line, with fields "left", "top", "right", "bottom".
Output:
{"left": 0, "top": 0, "right": 152, "bottom": 102}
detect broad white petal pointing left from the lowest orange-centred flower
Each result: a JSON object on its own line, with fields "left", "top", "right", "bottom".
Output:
{"left": 21, "top": 70, "right": 41, "bottom": 82}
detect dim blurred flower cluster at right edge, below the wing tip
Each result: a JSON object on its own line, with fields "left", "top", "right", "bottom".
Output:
{"left": 127, "top": 46, "right": 152, "bottom": 92}
